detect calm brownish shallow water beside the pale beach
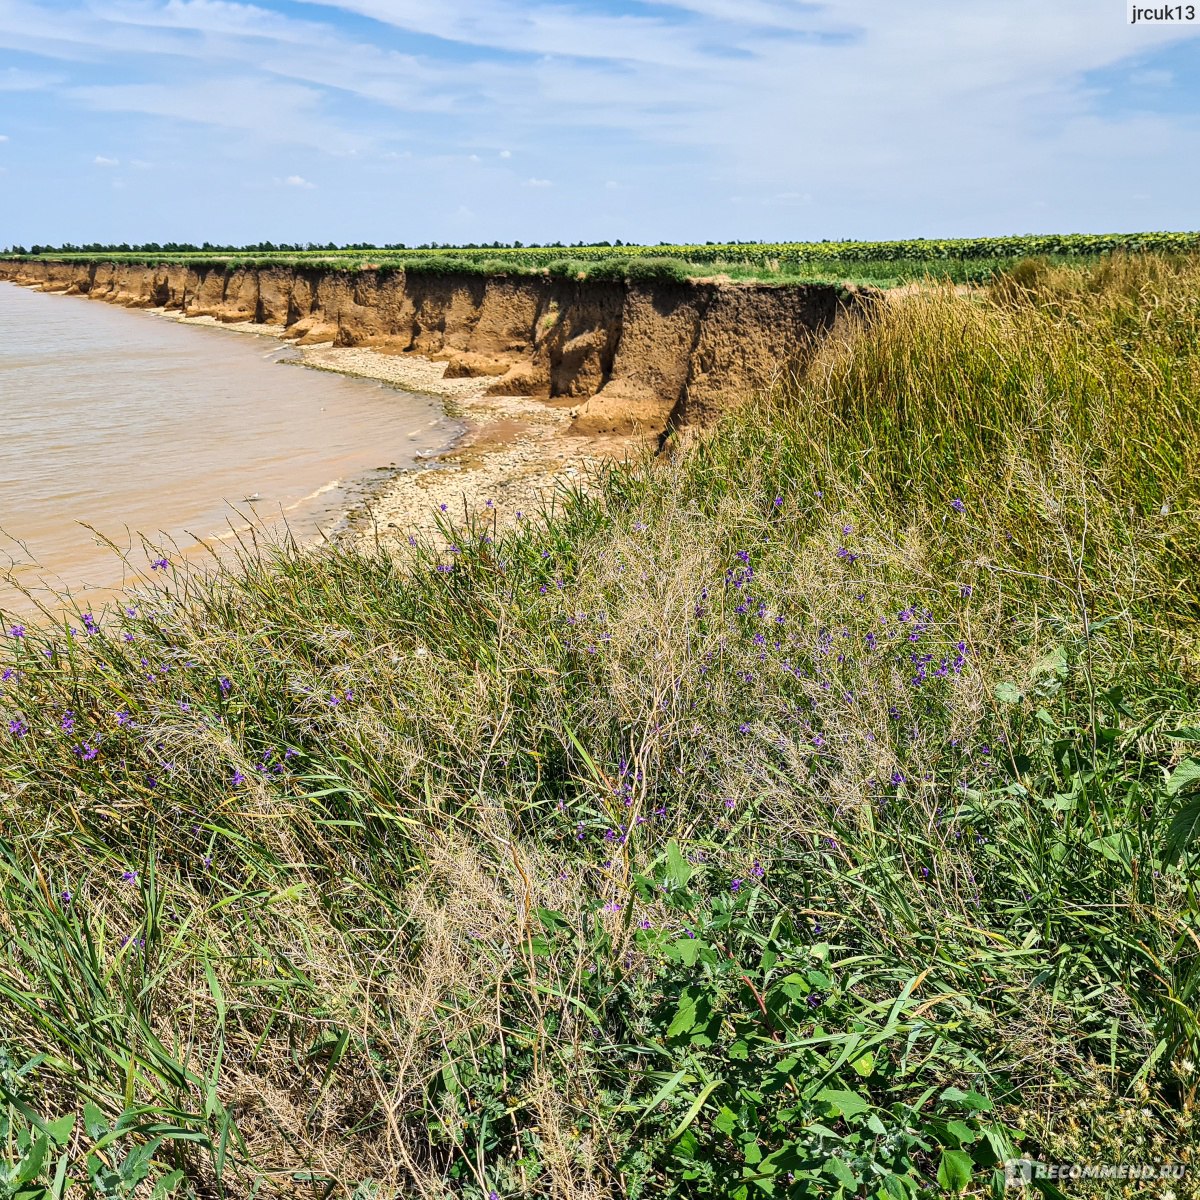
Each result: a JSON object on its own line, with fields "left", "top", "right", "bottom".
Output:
{"left": 0, "top": 283, "right": 457, "bottom": 612}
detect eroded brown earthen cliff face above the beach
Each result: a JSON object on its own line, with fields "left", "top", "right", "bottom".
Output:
{"left": 0, "top": 260, "right": 865, "bottom": 434}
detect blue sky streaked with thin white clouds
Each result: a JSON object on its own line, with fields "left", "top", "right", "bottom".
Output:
{"left": 0, "top": 0, "right": 1200, "bottom": 246}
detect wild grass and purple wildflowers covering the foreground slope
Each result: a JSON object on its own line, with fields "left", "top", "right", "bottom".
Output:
{"left": 0, "top": 250, "right": 1200, "bottom": 1200}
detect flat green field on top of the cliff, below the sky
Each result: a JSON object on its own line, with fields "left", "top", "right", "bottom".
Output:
{"left": 13, "top": 233, "right": 1200, "bottom": 287}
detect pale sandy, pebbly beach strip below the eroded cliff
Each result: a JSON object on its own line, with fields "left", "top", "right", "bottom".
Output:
{"left": 168, "top": 308, "right": 646, "bottom": 547}
